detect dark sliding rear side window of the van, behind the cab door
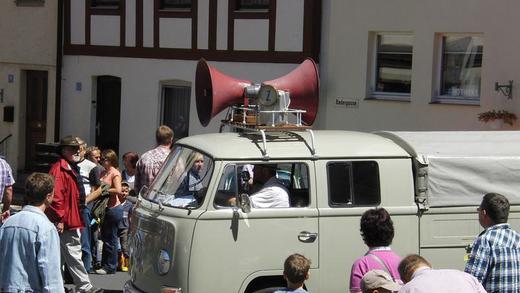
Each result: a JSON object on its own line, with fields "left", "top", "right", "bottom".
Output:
{"left": 327, "top": 161, "right": 381, "bottom": 207}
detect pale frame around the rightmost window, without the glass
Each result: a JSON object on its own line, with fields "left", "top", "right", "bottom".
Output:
{"left": 431, "top": 33, "right": 484, "bottom": 105}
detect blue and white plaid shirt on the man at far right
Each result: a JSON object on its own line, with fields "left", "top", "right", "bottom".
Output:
{"left": 465, "top": 223, "right": 520, "bottom": 293}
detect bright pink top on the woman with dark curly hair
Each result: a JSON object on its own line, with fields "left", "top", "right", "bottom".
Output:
{"left": 350, "top": 249, "right": 402, "bottom": 292}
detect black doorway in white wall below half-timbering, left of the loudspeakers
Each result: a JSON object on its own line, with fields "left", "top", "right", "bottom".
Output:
{"left": 96, "top": 76, "right": 121, "bottom": 154}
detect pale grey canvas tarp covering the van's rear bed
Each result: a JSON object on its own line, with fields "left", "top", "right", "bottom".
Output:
{"left": 377, "top": 131, "right": 520, "bottom": 207}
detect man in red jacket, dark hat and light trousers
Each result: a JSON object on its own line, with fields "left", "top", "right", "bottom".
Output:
{"left": 45, "top": 136, "right": 102, "bottom": 293}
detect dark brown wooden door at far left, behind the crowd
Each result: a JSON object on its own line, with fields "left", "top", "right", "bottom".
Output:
{"left": 25, "top": 70, "right": 48, "bottom": 170}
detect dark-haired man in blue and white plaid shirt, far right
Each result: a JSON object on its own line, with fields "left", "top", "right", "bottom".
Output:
{"left": 465, "top": 193, "right": 520, "bottom": 293}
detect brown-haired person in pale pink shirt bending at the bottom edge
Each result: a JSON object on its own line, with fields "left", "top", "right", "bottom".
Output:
{"left": 397, "top": 254, "right": 486, "bottom": 293}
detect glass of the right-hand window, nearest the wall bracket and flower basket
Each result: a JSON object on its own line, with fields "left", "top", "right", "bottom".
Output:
{"left": 439, "top": 35, "right": 483, "bottom": 100}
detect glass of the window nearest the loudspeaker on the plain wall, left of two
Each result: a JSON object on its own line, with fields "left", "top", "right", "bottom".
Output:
{"left": 372, "top": 34, "right": 413, "bottom": 99}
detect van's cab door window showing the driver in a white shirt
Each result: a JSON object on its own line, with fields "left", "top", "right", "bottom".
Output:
{"left": 215, "top": 163, "right": 309, "bottom": 208}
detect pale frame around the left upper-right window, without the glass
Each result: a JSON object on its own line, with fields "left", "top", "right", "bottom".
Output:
{"left": 367, "top": 31, "right": 415, "bottom": 102}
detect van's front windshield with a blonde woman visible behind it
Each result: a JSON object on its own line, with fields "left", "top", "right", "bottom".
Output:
{"left": 144, "top": 146, "right": 213, "bottom": 208}
